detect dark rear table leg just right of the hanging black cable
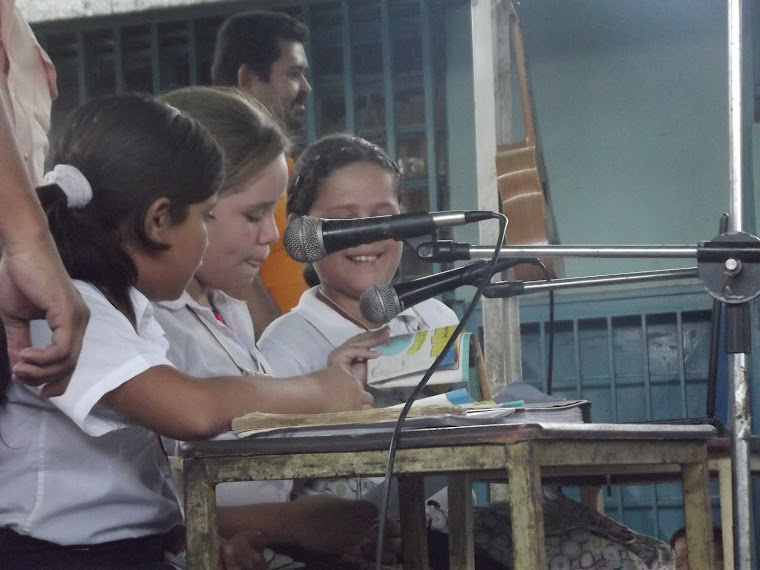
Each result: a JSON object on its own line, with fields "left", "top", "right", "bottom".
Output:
{"left": 398, "top": 475, "right": 428, "bottom": 570}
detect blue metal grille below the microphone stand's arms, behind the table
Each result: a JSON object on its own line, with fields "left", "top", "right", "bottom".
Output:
{"left": 521, "top": 286, "right": 725, "bottom": 539}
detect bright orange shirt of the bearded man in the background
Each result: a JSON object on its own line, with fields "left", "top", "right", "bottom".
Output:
{"left": 259, "top": 158, "right": 309, "bottom": 315}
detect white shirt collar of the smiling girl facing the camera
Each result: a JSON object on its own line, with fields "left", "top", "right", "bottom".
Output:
{"left": 293, "top": 286, "right": 424, "bottom": 346}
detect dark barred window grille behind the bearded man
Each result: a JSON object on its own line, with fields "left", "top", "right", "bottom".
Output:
{"left": 34, "top": 0, "right": 449, "bottom": 277}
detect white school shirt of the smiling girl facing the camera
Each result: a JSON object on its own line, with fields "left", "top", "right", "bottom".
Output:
{"left": 259, "top": 286, "right": 459, "bottom": 384}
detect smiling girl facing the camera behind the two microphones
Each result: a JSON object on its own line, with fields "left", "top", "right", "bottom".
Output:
{"left": 259, "top": 134, "right": 458, "bottom": 406}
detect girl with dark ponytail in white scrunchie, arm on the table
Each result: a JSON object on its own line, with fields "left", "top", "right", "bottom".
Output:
{"left": 0, "top": 91, "right": 371, "bottom": 568}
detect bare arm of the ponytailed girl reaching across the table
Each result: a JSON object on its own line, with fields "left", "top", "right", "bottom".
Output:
{"left": 101, "top": 365, "right": 372, "bottom": 441}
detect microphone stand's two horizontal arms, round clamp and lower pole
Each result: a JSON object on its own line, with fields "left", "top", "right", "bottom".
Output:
{"left": 417, "top": 231, "right": 760, "bottom": 570}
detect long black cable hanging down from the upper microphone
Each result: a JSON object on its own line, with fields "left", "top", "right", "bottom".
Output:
{"left": 375, "top": 212, "right": 507, "bottom": 570}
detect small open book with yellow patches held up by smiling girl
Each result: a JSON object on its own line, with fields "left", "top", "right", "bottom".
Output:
{"left": 367, "top": 325, "right": 470, "bottom": 388}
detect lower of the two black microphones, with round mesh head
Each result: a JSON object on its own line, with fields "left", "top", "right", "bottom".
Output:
{"left": 359, "top": 259, "right": 515, "bottom": 324}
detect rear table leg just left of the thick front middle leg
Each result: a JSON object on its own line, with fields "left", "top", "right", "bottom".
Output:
{"left": 449, "top": 473, "right": 475, "bottom": 570}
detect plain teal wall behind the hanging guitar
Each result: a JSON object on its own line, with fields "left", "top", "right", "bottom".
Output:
{"left": 447, "top": 0, "right": 757, "bottom": 276}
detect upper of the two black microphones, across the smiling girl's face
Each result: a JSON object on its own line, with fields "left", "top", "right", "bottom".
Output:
{"left": 282, "top": 210, "right": 494, "bottom": 263}
